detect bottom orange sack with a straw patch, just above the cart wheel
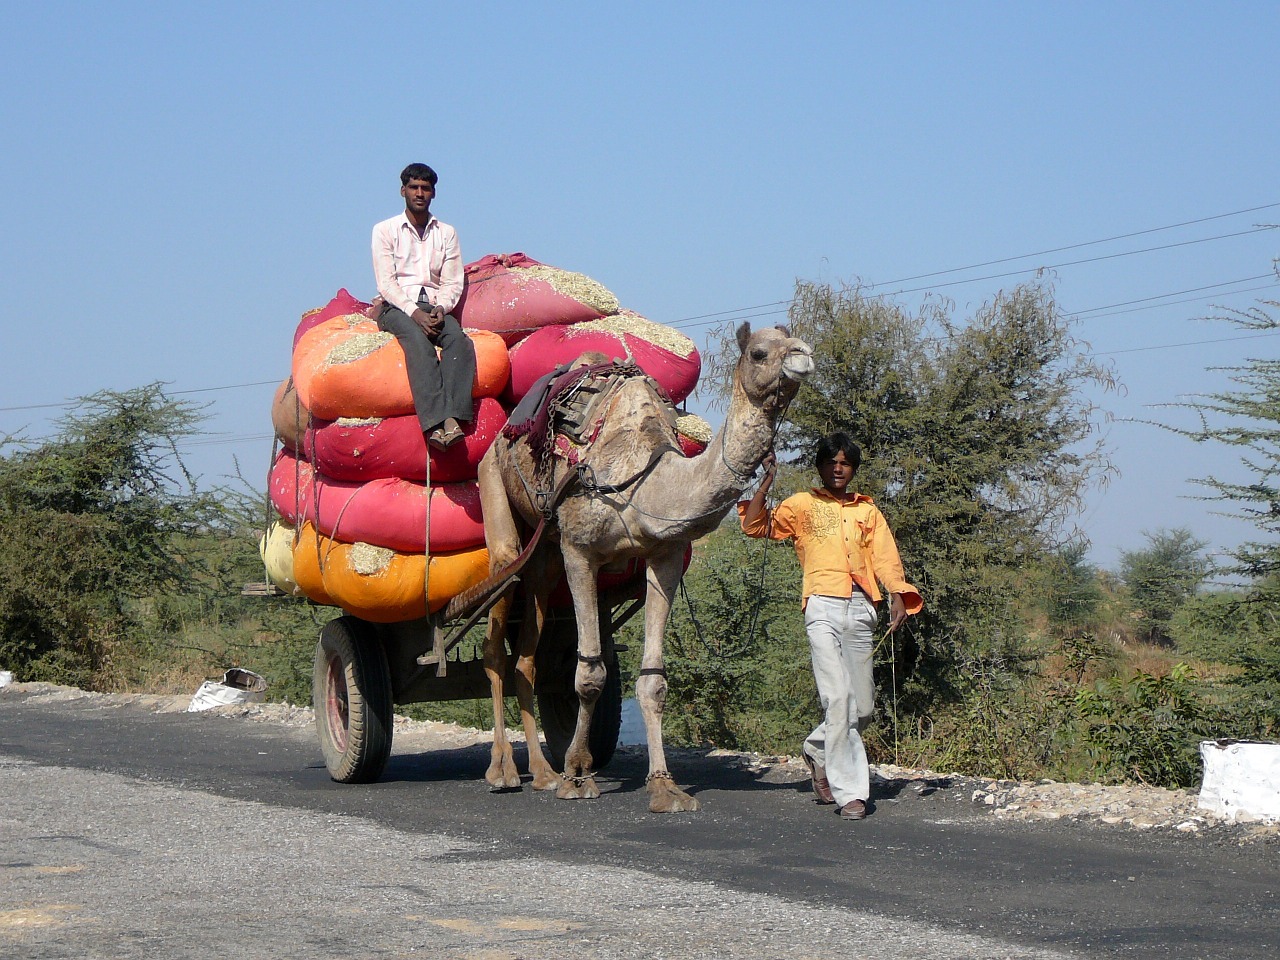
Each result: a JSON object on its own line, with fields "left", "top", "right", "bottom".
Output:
{"left": 293, "top": 524, "right": 489, "bottom": 623}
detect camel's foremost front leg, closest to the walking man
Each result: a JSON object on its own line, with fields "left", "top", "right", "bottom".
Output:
{"left": 636, "top": 545, "right": 698, "bottom": 813}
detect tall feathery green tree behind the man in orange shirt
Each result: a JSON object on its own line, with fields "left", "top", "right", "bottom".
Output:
{"left": 713, "top": 282, "right": 1115, "bottom": 710}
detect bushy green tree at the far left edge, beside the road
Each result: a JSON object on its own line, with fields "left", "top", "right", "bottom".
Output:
{"left": 0, "top": 384, "right": 223, "bottom": 685}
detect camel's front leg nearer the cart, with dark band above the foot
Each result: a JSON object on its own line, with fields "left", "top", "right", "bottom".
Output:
{"left": 556, "top": 544, "right": 604, "bottom": 800}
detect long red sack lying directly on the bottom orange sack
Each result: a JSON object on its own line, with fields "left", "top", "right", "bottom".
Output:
{"left": 269, "top": 451, "right": 484, "bottom": 554}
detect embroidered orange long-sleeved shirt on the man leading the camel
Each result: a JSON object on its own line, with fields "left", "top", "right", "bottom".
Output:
{"left": 737, "top": 488, "right": 924, "bottom": 613}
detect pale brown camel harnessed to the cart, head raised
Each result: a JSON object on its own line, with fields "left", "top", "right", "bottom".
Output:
{"left": 479, "top": 324, "right": 813, "bottom": 813}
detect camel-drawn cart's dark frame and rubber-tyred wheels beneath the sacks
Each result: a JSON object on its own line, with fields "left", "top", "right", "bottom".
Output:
{"left": 311, "top": 572, "right": 644, "bottom": 783}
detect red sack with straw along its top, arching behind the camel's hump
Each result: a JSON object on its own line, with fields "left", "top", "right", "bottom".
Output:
{"left": 503, "top": 311, "right": 703, "bottom": 403}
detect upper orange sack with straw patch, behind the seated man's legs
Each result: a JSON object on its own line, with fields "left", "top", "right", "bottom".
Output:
{"left": 293, "top": 314, "right": 511, "bottom": 420}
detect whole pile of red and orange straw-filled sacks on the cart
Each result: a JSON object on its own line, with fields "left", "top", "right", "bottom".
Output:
{"left": 262, "top": 253, "right": 710, "bottom": 622}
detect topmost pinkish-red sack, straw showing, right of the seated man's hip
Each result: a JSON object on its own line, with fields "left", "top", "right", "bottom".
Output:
{"left": 453, "top": 253, "right": 618, "bottom": 344}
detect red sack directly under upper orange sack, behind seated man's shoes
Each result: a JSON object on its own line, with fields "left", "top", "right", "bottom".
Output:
{"left": 305, "top": 397, "right": 507, "bottom": 484}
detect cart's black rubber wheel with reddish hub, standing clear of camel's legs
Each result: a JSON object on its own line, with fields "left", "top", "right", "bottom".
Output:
{"left": 311, "top": 617, "right": 392, "bottom": 783}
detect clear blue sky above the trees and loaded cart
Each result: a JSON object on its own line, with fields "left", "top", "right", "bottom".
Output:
{"left": 0, "top": 1, "right": 1280, "bottom": 568}
